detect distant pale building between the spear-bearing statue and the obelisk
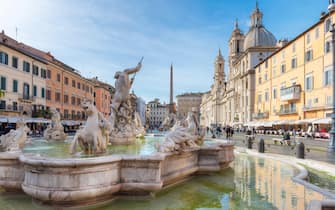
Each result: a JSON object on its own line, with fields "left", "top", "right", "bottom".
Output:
{"left": 147, "top": 98, "right": 170, "bottom": 129}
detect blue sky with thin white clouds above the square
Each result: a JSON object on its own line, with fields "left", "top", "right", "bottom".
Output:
{"left": 0, "top": 0, "right": 328, "bottom": 102}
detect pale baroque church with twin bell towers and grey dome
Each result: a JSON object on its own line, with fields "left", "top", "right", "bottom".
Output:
{"left": 200, "top": 3, "right": 280, "bottom": 126}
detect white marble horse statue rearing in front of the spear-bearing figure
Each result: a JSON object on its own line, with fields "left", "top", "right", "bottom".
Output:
{"left": 71, "top": 100, "right": 110, "bottom": 154}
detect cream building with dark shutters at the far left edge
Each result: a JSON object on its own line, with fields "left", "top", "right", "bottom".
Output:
{"left": 0, "top": 38, "right": 47, "bottom": 116}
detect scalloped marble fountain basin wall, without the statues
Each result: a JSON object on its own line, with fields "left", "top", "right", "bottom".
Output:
{"left": 0, "top": 143, "right": 234, "bottom": 206}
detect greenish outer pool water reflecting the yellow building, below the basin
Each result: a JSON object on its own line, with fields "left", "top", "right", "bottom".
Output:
{"left": 0, "top": 151, "right": 330, "bottom": 210}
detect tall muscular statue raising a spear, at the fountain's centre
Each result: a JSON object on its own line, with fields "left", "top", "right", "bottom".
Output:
{"left": 109, "top": 57, "right": 143, "bottom": 144}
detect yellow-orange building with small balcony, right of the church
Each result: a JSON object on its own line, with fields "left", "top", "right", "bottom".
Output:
{"left": 253, "top": 9, "right": 335, "bottom": 121}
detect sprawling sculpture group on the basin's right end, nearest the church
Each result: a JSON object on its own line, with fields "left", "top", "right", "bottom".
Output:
{"left": 156, "top": 112, "right": 204, "bottom": 152}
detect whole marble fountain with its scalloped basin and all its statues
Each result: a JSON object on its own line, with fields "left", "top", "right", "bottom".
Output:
{"left": 0, "top": 61, "right": 234, "bottom": 206}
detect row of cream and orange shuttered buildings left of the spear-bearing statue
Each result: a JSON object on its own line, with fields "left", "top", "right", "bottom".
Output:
{"left": 0, "top": 31, "right": 110, "bottom": 120}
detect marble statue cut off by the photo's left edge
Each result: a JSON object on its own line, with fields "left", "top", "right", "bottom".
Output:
{"left": 0, "top": 119, "right": 30, "bottom": 152}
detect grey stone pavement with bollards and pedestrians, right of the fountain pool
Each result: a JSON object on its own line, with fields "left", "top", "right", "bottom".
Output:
{"left": 207, "top": 133, "right": 335, "bottom": 165}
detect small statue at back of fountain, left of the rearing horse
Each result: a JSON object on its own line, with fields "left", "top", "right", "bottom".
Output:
{"left": 43, "top": 108, "right": 67, "bottom": 141}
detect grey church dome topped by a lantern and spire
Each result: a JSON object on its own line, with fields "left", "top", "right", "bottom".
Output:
{"left": 244, "top": 2, "right": 277, "bottom": 50}
